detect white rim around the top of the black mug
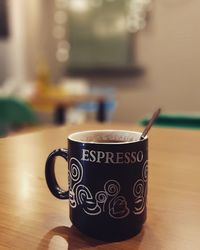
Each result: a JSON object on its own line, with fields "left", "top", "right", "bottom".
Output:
{"left": 67, "top": 129, "right": 148, "bottom": 145}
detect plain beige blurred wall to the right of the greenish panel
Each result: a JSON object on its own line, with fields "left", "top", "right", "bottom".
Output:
{"left": 115, "top": 0, "right": 200, "bottom": 121}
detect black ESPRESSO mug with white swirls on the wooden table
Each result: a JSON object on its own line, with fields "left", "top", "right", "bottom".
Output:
{"left": 45, "top": 130, "right": 148, "bottom": 241}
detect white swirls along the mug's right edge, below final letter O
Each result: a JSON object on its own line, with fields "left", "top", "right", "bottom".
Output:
{"left": 133, "top": 161, "right": 148, "bottom": 215}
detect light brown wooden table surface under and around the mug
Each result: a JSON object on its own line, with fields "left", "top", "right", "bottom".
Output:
{"left": 0, "top": 124, "right": 200, "bottom": 250}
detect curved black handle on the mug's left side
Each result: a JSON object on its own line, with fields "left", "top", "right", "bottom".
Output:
{"left": 45, "top": 148, "right": 69, "bottom": 200}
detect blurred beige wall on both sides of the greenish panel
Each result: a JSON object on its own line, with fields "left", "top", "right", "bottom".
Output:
{"left": 0, "top": 0, "right": 200, "bottom": 122}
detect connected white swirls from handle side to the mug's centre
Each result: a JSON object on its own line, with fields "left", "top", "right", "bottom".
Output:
{"left": 69, "top": 157, "right": 130, "bottom": 219}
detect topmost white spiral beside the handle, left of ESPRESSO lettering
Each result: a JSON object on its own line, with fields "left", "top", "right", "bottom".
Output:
{"left": 69, "top": 157, "right": 83, "bottom": 182}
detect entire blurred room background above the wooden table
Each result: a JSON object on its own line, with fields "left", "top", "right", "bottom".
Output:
{"left": 0, "top": 0, "right": 200, "bottom": 135}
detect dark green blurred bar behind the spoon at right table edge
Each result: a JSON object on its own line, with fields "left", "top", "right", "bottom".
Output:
{"left": 139, "top": 113, "right": 200, "bottom": 129}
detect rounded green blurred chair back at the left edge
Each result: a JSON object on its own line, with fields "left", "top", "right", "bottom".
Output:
{"left": 0, "top": 97, "right": 38, "bottom": 137}
